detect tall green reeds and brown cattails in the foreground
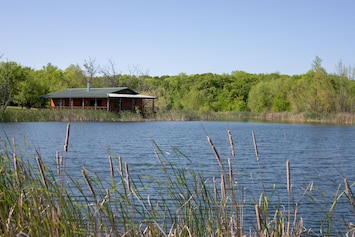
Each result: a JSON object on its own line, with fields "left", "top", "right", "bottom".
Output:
{"left": 0, "top": 124, "right": 355, "bottom": 237}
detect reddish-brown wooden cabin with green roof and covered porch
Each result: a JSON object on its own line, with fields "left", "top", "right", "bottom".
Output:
{"left": 40, "top": 83, "right": 155, "bottom": 114}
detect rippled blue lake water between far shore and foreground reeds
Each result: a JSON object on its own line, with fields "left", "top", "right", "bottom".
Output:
{"left": 0, "top": 122, "right": 355, "bottom": 234}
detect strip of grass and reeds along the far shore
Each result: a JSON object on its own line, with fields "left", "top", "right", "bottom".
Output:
{"left": 0, "top": 107, "right": 355, "bottom": 125}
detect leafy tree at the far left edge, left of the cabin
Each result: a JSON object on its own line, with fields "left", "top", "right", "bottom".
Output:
{"left": 0, "top": 62, "right": 26, "bottom": 113}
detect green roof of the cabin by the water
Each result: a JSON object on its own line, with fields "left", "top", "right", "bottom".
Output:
{"left": 40, "top": 87, "right": 138, "bottom": 99}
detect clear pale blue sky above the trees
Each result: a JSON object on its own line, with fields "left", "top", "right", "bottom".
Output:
{"left": 0, "top": 0, "right": 355, "bottom": 76}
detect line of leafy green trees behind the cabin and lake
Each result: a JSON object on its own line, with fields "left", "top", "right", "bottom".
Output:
{"left": 0, "top": 57, "right": 355, "bottom": 113}
